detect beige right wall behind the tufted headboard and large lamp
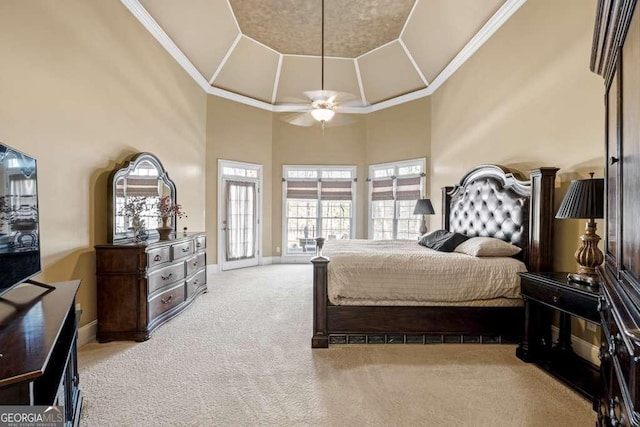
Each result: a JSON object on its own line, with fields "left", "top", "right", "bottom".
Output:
{"left": 431, "top": 0, "right": 604, "bottom": 340}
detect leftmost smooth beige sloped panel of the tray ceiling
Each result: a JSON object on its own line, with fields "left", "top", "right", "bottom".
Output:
{"left": 140, "top": 0, "right": 239, "bottom": 80}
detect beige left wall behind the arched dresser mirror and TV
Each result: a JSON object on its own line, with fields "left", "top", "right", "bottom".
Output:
{"left": 0, "top": 0, "right": 206, "bottom": 324}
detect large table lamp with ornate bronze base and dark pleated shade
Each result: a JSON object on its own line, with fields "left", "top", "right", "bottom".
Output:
{"left": 556, "top": 172, "right": 604, "bottom": 287}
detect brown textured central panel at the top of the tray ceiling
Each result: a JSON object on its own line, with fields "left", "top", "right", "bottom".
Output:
{"left": 229, "top": 0, "right": 415, "bottom": 58}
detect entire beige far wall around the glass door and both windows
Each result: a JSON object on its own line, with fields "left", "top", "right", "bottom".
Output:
{"left": 206, "top": 96, "right": 430, "bottom": 263}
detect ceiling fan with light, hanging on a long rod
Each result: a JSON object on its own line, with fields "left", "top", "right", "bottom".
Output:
{"left": 284, "top": 0, "right": 359, "bottom": 130}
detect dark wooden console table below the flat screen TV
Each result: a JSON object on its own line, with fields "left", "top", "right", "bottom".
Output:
{"left": 0, "top": 280, "right": 82, "bottom": 426}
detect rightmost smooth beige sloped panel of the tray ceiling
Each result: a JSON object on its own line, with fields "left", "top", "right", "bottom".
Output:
{"left": 402, "top": 0, "right": 506, "bottom": 82}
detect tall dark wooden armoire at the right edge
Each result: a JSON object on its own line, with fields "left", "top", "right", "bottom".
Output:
{"left": 591, "top": 0, "right": 640, "bottom": 426}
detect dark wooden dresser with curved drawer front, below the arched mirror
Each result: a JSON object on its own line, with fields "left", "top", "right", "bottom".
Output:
{"left": 96, "top": 233, "right": 207, "bottom": 342}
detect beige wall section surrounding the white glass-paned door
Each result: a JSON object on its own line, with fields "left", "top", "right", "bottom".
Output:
{"left": 206, "top": 96, "right": 272, "bottom": 264}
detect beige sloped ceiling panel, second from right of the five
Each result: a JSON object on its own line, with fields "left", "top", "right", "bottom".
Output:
{"left": 358, "top": 42, "right": 425, "bottom": 104}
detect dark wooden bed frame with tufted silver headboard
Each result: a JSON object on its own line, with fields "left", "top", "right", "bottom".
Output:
{"left": 311, "top": 165, "right": 558, "bottom": 348}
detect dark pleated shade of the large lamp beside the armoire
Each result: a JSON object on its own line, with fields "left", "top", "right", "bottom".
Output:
{"left": 556, "top": 178, "right": 604, "bottom": 219}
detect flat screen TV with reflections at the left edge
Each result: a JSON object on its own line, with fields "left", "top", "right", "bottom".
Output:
{"left": 0, "top": 143, "right": 41, "bottom": 295}
